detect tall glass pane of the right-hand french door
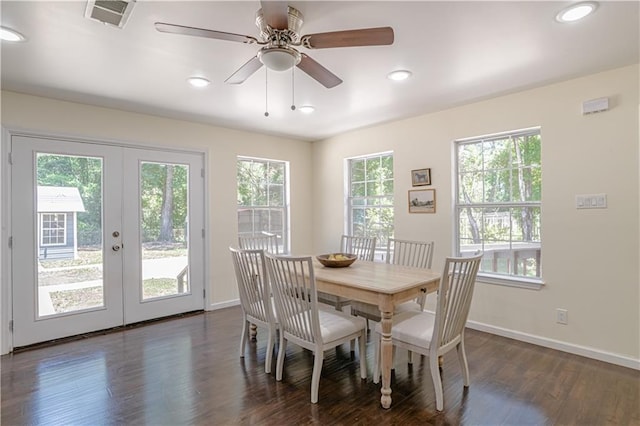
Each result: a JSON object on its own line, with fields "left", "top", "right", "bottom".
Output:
{"left": 140, "top": 162, "right": 191, "bottom": 300}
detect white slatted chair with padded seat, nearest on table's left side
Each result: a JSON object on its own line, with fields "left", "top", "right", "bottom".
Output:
{"left": 265, "top": 253, "right": 367, "bottom": 404}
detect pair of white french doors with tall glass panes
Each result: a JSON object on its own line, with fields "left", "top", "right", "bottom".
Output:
{"left": 11, "top": 136, "right": 204, "bottom": 347}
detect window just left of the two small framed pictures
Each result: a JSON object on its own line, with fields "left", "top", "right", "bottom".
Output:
{"left": 347, "top": 153, "right": 393, "bottom": 258}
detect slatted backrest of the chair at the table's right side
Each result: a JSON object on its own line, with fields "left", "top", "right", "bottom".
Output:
{"left": 432, "top": 253, "right": 482, "bottom": 347}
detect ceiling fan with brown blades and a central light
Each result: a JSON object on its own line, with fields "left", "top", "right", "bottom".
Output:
{"left": 155, "top": 0, "right": 394, "bottom": 88}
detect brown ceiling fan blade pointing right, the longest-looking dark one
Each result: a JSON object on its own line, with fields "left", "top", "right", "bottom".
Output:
{"left": 301, "top": 27, "right": 393, "bottom": 49}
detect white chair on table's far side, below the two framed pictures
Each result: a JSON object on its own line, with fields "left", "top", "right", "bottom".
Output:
{"left": 351, "top": 238, "right": 434, "bottom": 322}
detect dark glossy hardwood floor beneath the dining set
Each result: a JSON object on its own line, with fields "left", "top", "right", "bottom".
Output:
{"left": 1, "top": 307, "right": 640, "bottom": 426}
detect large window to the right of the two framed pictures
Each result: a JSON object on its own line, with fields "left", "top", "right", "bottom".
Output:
{"left": 454, "top": 128, "right": 542, "bottom": 286}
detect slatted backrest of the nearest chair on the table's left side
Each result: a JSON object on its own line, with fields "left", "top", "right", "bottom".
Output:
{"left": 265, "top": 253, "right": 322, "bottom": 344}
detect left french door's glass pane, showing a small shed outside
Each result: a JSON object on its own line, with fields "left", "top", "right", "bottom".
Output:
{"left": 35, "top": 153, "right": 104, "bottom": 317}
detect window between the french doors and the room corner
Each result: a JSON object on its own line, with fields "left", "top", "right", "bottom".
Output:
{"left": 238, "top": 157, "right": 289, "bottom": 253}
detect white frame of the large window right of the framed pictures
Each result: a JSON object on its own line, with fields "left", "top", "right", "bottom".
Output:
{"left": 452, "top": 126, "right": 545, "bottom": 289}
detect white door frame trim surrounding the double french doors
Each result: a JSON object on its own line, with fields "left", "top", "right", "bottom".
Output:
{"left": 0, "top": 126, "right": 211, "bottom": 355}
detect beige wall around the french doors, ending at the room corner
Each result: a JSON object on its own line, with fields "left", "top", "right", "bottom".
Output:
{"left": 2, "top": 92, "right": 311, "bottom": 312}
